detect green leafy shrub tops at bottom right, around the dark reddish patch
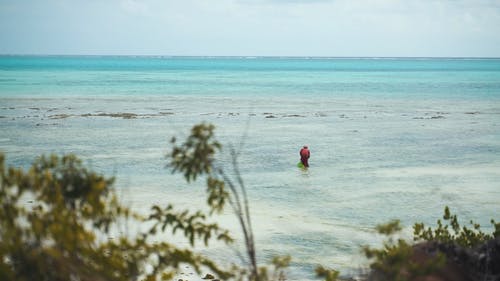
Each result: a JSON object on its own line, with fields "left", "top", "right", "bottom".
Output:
{"left": 363, "top": 206, "right": 500, "bottom": 281}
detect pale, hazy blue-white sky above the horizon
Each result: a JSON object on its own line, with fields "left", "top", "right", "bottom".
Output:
{"left": 0, "top": 0, "right": 500, "bottom": 57}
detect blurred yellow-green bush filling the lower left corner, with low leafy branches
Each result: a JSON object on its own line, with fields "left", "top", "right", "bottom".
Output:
{"left": 0, "top": 155, "right": 231, "bottom": 281}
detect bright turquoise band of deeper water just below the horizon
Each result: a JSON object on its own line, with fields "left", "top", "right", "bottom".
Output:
{"left": 0, "top": 56, "right": 500, "bottom": 98}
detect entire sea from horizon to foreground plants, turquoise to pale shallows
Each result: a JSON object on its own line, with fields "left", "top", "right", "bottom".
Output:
{"left": 0, "top": 56, "right": 500, "bottom": 280}
